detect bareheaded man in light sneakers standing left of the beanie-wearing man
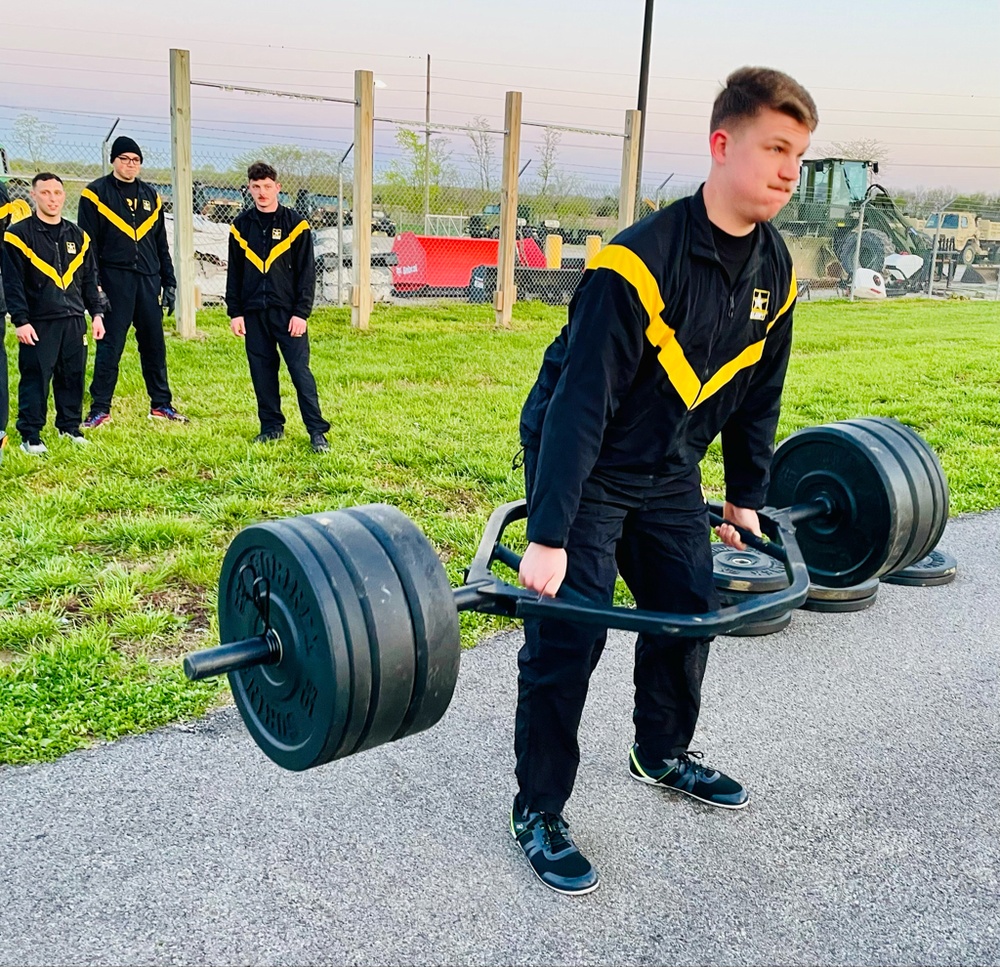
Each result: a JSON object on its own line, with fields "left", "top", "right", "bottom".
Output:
{"left": 4, "top": 172, "right": 104, "bottom": 456}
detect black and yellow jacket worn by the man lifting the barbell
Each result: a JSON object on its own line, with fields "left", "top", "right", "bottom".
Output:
{"left": 520, "top": 189, "right": 796, "bottom": 547}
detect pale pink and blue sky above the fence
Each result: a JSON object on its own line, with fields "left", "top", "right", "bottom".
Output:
{"left": 0, "top": 0, "right": 1000, "bottom": 194}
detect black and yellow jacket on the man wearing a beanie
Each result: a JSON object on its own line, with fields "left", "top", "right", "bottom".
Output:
{"left": 77, "top": 174, "right": 177, "bottom": 289}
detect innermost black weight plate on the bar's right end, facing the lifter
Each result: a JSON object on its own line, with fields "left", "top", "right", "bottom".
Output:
{"left": 767, "top": 423, "right": 912, "bottom": 587}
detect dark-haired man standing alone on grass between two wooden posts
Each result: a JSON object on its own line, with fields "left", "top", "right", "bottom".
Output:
{"left": 226, "top": 161, "right": 330, "bottom": 453}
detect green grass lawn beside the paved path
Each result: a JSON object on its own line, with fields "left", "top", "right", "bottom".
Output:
{"left": 0, "top": 301, "right": 1000, "bottom": 764}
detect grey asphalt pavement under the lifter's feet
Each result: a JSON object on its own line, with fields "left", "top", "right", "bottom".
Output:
{"left": 0, "top": 513, "right": 1000, "bottom": 965}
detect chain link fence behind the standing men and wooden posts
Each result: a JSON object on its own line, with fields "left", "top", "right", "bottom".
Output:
{"left": 9, "top": 89, "right": 1000, "bottom": 305}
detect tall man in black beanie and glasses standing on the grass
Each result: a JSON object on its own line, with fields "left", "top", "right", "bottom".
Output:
{"left": 79, "top": 137, "right": 188, "bottom": 429}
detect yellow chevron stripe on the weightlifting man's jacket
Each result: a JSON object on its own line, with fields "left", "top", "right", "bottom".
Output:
{"left": 587, "top": 245, "right": 798, "bottom": 410}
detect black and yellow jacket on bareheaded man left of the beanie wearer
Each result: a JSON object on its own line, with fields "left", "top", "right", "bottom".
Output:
{"left": 3, "top": 215, "right": 102, "bottom": 326}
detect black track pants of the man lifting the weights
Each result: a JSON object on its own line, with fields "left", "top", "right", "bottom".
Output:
{"left": 514, "top": 450, "right": 718, "bottom": 812}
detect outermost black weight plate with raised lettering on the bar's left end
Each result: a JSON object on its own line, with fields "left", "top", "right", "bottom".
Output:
{"left": 219, "top": 521, "right": 351, "bottom": 772}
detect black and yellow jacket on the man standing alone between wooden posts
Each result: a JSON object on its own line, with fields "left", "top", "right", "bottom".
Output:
{"left": 226, "top": 205, "right": 316, "bottom": 319}
